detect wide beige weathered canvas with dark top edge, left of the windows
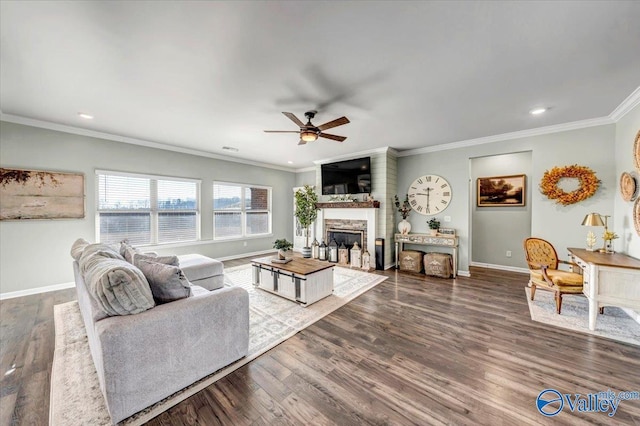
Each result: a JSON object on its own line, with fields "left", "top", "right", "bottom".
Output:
{"left": 0, "top": 168, "right": 84, "bottom": 220}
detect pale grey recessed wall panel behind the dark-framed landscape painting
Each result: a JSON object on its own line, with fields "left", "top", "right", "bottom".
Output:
{"left": 470, "top": 151, "right": 533, "bottom": 268}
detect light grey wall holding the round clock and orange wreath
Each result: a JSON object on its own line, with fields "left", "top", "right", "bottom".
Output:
{"left": 398, "top": 124, "right": 617, "bottom": 271}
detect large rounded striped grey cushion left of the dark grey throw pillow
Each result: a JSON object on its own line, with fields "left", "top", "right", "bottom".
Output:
{"left": 78, "top": 251, "right": 155, "bottom": 316}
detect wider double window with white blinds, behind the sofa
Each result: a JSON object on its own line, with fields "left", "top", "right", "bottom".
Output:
{"left": 96, "top": 171, "right": 200, "bottom": 244}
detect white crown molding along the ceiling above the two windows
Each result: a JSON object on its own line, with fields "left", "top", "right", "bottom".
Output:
{"left": 0, "top": 112, "right": 295, "bottom": 173}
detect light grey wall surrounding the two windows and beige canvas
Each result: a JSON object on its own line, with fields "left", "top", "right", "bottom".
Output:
{"left": 0, "top": 122, "right": 295, "bottom": 293}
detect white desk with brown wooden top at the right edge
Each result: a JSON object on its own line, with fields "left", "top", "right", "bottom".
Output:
{"left": 568, "top": 248, "right": 640, "bottom": 330}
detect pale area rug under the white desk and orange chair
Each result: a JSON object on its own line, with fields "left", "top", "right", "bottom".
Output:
{"left": 525, "top": 287, "right": 640, "bottom": 346}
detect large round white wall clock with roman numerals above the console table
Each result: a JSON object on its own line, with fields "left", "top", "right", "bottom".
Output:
{"left": 407, "top": 175, "right": 452, "bottom": 216}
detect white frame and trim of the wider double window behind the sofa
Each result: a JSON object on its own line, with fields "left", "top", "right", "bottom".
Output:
{"left": 95, "top": 169, "right": 202, "bottom": 247}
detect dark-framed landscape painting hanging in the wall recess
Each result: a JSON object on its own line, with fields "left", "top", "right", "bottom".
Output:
{"left": 476, "top": 175, "right": 526, "bottom": 207}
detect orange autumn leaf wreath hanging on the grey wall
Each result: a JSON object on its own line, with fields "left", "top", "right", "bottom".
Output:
{"left": 540, "top": 164, "right": 600, "bottom": 206}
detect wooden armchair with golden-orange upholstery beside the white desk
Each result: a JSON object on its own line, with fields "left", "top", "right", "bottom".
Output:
{"left": 524, "top": 238, "right": 582, "bottom": 314}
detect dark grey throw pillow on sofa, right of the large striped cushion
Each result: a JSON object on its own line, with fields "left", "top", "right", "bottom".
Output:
{"left": 138, "top": 260, "right": 191, "bottom": 304}
